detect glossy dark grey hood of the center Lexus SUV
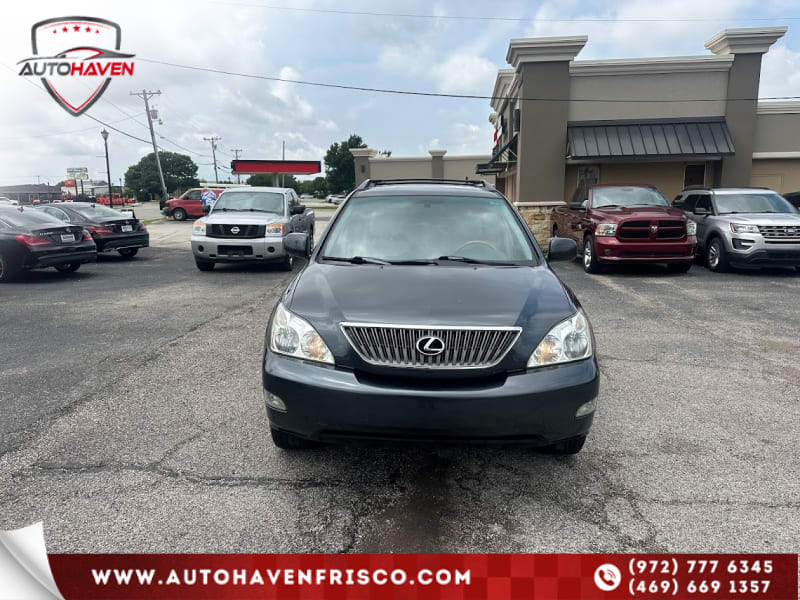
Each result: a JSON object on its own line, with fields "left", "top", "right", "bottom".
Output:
{"left": 284, "top": 262, "right": 578, "bottom": 371}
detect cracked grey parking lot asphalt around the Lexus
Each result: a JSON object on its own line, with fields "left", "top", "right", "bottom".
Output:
{"left": 0, "top": 222, "right": 800, "bottom": 552}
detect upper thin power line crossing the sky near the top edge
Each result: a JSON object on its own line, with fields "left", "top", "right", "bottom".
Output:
{"left": 200, "top": 0, "right": 800, "bottom": 23}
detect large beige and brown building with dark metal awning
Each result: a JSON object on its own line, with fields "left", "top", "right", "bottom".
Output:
{"left": 477, "top": 27, "right": 800, "bottom": 243}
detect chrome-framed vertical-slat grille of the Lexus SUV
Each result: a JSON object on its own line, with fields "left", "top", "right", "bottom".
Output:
{"left": 341, "top": 323, "right": 521, "bottom": 369}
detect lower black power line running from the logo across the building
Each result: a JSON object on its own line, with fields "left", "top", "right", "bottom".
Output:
{"left": 137, "top": 57, "right": 800, "bottom": 104}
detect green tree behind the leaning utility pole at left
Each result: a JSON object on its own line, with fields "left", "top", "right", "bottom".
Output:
{"left": 125, "top": 150, "right": 200, "bottom": 201}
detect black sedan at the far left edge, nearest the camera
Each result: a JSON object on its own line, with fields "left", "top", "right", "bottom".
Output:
{"left": 0, "top": 206, "right": 97, "bottom": 283}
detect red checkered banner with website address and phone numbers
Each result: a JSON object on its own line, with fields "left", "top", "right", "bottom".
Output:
{"left": 49, "top": 554, "right": 798, "bottom": 600}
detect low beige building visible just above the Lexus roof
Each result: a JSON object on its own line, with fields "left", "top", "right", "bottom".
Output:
{"left": 350, "top": 148, "right": 495, "bottom": 185}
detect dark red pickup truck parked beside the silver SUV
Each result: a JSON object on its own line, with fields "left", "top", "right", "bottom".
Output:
{"left": 552, "top": 185, "right": 697, "bottom": 273}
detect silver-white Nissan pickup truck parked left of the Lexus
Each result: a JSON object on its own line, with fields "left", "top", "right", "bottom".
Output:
{"left": 192, "top": 187, "right": 314, "bottom": 271}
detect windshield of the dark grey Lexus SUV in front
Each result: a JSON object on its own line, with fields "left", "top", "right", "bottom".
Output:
{"left": 321, "top": 196, "right": 535, "bottom": 263}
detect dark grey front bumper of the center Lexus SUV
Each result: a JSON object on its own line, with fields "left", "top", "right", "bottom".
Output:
{"left": 263, "top": 352, "right": 599, "bottom": 446}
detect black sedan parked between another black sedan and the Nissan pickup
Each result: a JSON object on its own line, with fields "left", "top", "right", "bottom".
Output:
{"left": 38, "top": 202, "right": 150, "bottom": 258}
